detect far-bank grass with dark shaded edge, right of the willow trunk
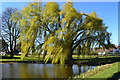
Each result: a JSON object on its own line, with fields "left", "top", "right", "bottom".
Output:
{"left": 73, "top": 55, "right": 120, "bottom": 65}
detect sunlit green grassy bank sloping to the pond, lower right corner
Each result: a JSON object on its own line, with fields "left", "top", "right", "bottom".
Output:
{"left": 72, "top": 62, "right": 120, "bottom": 80}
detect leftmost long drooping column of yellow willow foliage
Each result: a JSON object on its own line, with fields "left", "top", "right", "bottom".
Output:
{"left": 20, "top": 3, "right": 41, "bottom": 59}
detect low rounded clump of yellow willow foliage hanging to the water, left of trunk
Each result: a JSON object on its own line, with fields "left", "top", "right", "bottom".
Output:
{"left": 44, "top": 33, "right": 69, "bottom": 64}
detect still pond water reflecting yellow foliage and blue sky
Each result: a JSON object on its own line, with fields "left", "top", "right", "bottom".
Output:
{"left": 2, "top": 63, "right": 96, "bottom": 78}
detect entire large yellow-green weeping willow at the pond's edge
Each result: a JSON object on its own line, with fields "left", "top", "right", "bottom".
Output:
{"left": 20, "top": 2, "right": 110, "bottom": 64}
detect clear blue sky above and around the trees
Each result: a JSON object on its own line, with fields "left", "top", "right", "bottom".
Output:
{"left": 0, "top": 2, "right": 118, "bottom": 45}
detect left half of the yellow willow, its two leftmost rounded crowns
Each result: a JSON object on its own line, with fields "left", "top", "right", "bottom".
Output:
{"left": 20, "top": 2, "right": 59, "bottom": 58}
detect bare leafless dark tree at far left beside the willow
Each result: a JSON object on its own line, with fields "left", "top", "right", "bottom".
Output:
{"left": 2, "top": 8, "right": 20, "bottom": 57}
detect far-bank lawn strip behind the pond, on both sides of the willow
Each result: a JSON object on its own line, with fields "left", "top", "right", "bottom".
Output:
{"left": 0, "top": 55, "right": 120, "bottom": 65}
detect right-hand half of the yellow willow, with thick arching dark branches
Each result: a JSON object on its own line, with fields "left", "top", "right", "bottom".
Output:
{"left": 44, "top": 2, "right": 109, "bottom": 64}
